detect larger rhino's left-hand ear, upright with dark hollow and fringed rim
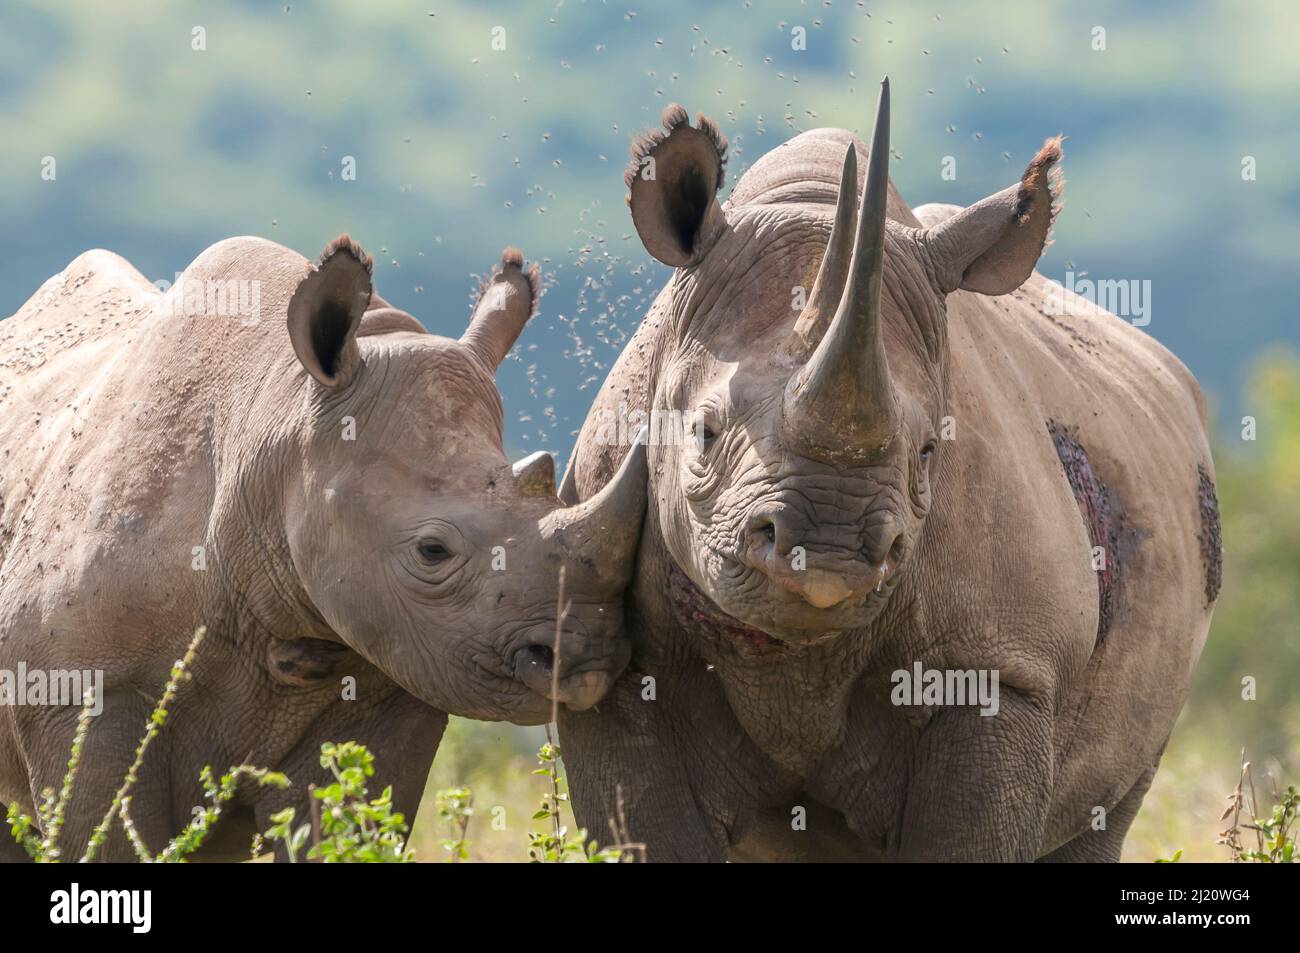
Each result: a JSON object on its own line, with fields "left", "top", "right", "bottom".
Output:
{"left": 623, "top": 103, "right": 727, "bottom": 268}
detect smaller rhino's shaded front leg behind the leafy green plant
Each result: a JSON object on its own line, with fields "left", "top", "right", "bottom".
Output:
{"left": 255, "top": 688, "right": 447, "bottom": 861}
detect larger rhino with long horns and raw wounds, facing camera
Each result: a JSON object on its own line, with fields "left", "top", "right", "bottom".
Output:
{"left": 560, "top": 82, "right": 1219, "bottom": 861}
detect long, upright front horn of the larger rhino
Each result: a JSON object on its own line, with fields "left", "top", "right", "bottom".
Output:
{"left": 785, "top": 77, "right": 898, "bottom": 459}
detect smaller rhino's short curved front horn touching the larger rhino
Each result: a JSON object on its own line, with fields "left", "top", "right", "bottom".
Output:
{"left": 546, "top": 428, "right": 649, "bottom": 588}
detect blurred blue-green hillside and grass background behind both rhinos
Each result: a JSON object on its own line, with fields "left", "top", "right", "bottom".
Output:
{"left": 0, "top": 0, "right": 1300, "bottom": 859}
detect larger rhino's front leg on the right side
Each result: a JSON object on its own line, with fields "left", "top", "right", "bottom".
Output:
{"left": 896, "top": 685, "right": 1053, "bottom": 861}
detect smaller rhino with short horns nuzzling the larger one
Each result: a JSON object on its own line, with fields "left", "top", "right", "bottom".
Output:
{"left": 0, "top": 237, "right": 645, "bottom": 858}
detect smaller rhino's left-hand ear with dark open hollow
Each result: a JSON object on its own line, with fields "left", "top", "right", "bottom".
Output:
{"left": 289, "top": 235, "right": 374, "bottom": 387}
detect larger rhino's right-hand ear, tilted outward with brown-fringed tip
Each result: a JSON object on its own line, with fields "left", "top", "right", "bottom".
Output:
{"left": 923, "top": 137, "right": 1062, "bottom": 295}
